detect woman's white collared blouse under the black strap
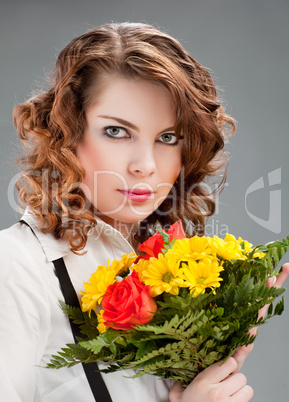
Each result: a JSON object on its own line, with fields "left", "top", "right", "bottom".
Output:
{"left": 0, "top": 212, "right": 172, "bottom": 402}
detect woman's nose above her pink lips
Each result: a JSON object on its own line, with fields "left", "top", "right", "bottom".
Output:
{"left": 128, "top": 145, "right": 157, "bottom": 177}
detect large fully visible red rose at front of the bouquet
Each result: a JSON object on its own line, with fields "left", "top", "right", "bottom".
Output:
{"left": 101, "top": 271, "right": 157, "bottom": 330}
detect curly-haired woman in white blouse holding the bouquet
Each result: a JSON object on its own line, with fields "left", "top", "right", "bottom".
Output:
{"left": 0, "top": 23, "right": 289, "bottom": 402}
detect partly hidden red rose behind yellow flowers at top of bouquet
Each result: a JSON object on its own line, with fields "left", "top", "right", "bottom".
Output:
{"left": 135, "top": 220, "right": 186, "bottom": 263}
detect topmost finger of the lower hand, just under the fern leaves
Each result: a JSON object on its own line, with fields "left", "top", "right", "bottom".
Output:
{"left": 197, "top": 357, "right": 238, "bottom": 384}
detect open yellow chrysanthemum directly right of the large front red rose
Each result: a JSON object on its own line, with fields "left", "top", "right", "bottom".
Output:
{"left": 142, "top": 253, "right": 183, "bottom": 297}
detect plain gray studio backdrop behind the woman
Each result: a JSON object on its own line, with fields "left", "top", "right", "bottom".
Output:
{"left": 0, "top": 0, "right": 289, "bottom": 402}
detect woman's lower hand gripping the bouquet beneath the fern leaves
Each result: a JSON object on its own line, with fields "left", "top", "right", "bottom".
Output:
{"left": 170, "top": 357, "right": 254, "bottom": 402}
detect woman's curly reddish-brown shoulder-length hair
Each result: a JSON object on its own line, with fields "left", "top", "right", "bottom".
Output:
{"left": 14, "top": 23, "right": 235, "bottom": 253}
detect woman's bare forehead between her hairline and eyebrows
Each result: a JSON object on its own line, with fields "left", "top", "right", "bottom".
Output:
{"left": 87, "top": 76, "right": 176, "bottom": 125}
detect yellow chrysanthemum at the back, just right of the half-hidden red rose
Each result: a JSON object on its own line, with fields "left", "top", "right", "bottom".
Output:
{"left": 168, "top": 236, "right": 214, "bottom": 261}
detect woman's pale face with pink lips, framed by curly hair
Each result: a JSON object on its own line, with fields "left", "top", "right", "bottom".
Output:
{"left": 76, "top": 77, "right": 182, "bottom": 232}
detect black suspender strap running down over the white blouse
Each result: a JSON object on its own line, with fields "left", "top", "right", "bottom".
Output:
{"left": 20, "top": 220, "right": 112, "bottom": 402}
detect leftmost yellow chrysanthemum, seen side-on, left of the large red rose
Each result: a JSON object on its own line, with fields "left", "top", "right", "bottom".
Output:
{"left": 80, "top": 260, "right": 123, "bottom": 311}
